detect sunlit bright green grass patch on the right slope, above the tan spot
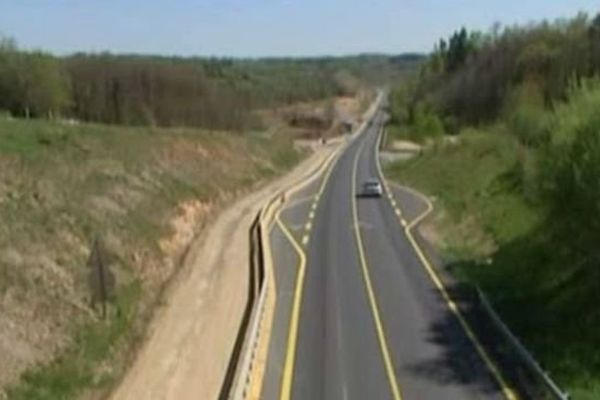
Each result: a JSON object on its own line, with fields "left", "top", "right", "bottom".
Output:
{"left": 388, "top": 131, "right": 531, "bottom": 253}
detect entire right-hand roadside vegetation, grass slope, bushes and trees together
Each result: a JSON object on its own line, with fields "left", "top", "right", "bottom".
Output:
{"left": 388, "top": 10, "right": 600, "bottom": 399}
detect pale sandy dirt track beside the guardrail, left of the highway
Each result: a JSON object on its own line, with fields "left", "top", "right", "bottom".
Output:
{"left": 111, "top": 141, "right": 338, "bottom": 400}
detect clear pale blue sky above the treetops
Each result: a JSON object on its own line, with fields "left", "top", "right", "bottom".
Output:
{"left": 0, "top": 0, "right": 600, "bottom": 57}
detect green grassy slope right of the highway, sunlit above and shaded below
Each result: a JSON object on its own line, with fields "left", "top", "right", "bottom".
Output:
{"left": 386, "top": 129, "right": 600, "bottom": 400}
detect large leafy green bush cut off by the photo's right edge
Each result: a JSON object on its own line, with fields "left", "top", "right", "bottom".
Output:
{"left": 541, "top": 80, "right": 600, "bottom": 251}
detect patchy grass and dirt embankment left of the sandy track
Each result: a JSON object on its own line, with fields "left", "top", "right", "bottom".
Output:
{"left": 0, "top": 120, "right": 299, "bottom": 399}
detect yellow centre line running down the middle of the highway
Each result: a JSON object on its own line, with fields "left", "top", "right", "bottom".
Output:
{"left": 351, "top": 141, "right": 402, "bottom": 400}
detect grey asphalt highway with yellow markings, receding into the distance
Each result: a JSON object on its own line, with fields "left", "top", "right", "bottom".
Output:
{"left": 261, "top": 109, "right": 516, "bottom": 400}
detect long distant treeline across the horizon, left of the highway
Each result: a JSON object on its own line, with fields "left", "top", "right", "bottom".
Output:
{"left": 0, "top": 39, "right": 412, "bottom": 129}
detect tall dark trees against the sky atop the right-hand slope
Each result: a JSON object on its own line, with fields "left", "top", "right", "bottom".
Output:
{"left": 396, "top": 14, "right": 600, "bottom": 133}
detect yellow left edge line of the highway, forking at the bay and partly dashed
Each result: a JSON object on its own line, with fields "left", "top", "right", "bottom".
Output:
{"left": 276, "top": 149, "right": 338, "bottom": 400}
